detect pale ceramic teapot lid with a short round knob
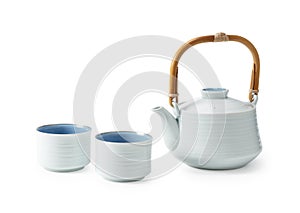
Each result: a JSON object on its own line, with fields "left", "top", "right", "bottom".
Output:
{"left": 179, "top": 88, "right": 255, "bottom": 114}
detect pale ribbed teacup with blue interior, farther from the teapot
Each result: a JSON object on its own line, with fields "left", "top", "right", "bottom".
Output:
{"left": 37, "top": 124, "right": 91, "bottom": 172}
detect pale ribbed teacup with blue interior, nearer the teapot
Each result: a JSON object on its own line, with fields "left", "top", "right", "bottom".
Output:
{"left": 95, "top": 131, "right": 152, "bottom": 182}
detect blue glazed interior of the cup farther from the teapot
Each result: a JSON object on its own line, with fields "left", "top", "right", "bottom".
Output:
{"left": 37, "top": 124, "right": 91, "bottom": 134}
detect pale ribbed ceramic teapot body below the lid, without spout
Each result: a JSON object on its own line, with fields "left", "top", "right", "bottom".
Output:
{"left": 173, "top": 103, "right": 262, "bottom": 169}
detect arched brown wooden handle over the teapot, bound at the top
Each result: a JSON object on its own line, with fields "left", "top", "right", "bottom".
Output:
{"left": 169, "top": 33, "right": 260, "bottom": 106}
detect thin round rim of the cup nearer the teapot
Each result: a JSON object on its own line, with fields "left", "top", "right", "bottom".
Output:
{"left": 95, "top": 131, "right": 153, "bottom": 144}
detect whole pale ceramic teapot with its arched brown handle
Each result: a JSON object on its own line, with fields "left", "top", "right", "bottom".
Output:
{"left": 153, "top": 33, "right": 262, "bottom": 169}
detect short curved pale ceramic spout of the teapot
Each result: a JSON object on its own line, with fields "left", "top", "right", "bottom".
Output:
{"left": 152, "top": 106, "right": 179, "bottom": 151}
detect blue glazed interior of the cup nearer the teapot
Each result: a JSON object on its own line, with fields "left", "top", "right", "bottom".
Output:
{"left": 96, "top": 131, "right": 152, "bottom": 143}
